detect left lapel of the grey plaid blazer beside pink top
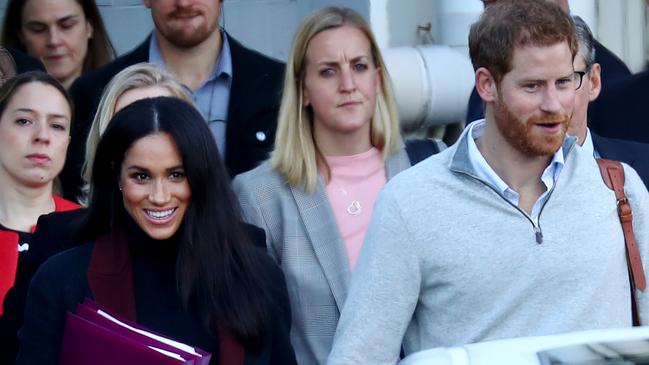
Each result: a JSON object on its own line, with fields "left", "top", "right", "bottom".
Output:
{"left": 291, "top": 180, "right": 351, "bottom": 310}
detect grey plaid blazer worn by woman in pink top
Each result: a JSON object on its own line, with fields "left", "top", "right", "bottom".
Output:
{"left": 234, "top": 148, "right": 410, "bottom": 364}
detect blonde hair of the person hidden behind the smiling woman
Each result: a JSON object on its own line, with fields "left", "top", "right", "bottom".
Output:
{"left": 79, "top": 62, "right": 194, "bottom": 203}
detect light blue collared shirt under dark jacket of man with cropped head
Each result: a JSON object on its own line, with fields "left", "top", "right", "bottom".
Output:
{"left": 149, "top": 30, "right": 232, "bottom": 158}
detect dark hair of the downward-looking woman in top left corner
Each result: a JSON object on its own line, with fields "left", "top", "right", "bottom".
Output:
{"left": 0, "top": 0, "right": 115, "bottom": 73}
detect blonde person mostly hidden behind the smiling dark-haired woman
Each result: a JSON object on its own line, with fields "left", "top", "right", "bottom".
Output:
{"left": 62, "top": 63, "right": 194, "bottom": 203}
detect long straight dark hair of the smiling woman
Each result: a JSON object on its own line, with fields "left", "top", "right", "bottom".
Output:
{"left": 84, "top": 97, "right": 271, "bottom": 344}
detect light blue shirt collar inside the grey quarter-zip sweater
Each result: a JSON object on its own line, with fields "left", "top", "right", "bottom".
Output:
{"left": 467, "top": 119, "right": 564, "bottom": 220}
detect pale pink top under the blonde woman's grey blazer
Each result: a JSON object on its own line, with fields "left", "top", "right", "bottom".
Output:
{"left": 325, "top": 147, "right": 387, "bottom": 270}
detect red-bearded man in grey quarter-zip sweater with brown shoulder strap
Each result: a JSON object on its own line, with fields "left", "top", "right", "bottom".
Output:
{"left": 328, "top": 0, "right": 649, "bottom": 364}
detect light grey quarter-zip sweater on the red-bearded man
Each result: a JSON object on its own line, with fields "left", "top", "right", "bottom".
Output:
{"left": 328, "top": 126, "right": 649, "bottom": 365}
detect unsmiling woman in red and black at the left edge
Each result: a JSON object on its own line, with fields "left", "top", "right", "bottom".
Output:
{"left": 0, "top": 69, "right": 79, "bottom": 365}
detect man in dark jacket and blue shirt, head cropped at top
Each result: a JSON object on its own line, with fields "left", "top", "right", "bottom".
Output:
{"left": 61, "top": 0, "right": 284, "bottom": 199}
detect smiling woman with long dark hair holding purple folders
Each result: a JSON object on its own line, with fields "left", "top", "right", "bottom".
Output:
{"left": 17, "top": 97, "right": 295, "bottom": 364}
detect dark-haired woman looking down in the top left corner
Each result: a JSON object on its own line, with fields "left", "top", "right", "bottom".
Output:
{"left": 0, "top": 0, "right": 115, "bottom": 89}
